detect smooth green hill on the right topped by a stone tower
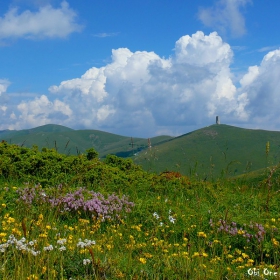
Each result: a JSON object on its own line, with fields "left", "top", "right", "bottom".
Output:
{"left": 134, "top": 125, "right": 280, "bottom": 178}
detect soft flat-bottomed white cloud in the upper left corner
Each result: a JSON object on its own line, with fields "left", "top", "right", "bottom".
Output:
{"left": 0, "top": 1, "right": 82, "bottom": 39}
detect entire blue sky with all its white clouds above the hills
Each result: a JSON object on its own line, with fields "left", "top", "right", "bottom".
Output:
{"left": 0, "top": 0, "right": 280, "bottom": 137}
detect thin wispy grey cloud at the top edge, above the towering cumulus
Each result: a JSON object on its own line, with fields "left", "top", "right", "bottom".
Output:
{"left": 198, "top": 0, "right": 252, "bottom": 37}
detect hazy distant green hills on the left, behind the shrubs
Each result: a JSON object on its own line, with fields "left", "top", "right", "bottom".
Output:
{"left": 0, "top": 124, "right": 172, "bottom": 158}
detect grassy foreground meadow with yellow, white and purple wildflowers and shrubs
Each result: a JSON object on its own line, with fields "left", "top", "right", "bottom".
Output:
{"left": 0, "top": 143, "right": 280, "bottom": 280}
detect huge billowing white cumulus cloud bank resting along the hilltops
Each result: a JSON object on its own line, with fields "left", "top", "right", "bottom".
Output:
{"left": 0, "top": 31, "right": 280, "bottom": 137}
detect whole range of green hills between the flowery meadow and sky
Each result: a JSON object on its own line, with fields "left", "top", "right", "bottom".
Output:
{"left": 3, "top": 124, "right": 280, "bottom": 179}
